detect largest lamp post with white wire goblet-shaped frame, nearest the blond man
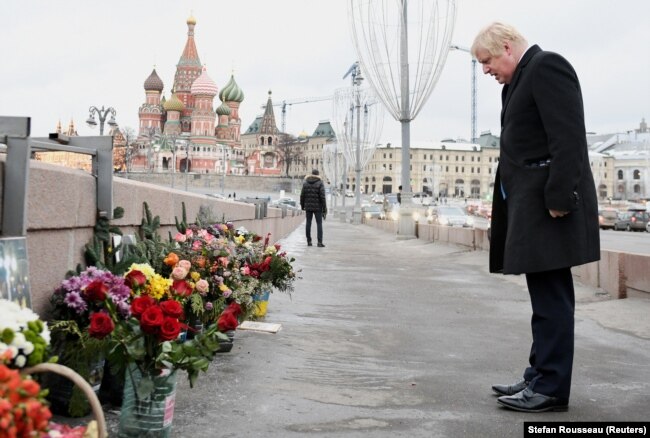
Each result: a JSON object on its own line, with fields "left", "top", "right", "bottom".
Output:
{"left": 349, "top": 0, "right": 456, "bottom": 238}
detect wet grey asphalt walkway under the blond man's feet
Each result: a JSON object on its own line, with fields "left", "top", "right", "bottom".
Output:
{"left": 107, "top": 220, "right": 650, "bottom": 438}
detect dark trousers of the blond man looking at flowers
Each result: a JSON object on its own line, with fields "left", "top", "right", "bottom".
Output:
{"left": 524, "top": 268, "right": 575, "bottom": 401}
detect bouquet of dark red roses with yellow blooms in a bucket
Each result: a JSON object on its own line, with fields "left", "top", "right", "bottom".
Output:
{"left": 89, "top": 264, "right": 227, "bottom": 397}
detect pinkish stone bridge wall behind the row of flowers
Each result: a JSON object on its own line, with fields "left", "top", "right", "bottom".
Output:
{"left": 0, "top": 156, "right": 304, "bottom": 313}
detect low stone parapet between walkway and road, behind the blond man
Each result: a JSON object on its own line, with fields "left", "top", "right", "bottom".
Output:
{"left": 364, "top": 218, "right": 650, "bottom": 298}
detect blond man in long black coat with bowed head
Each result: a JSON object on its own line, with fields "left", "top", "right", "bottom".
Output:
{"left": 472, "top": 23, "right": 600, "bottom": 412}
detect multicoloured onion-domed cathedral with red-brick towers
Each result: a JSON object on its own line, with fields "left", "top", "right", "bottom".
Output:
{"left": 130, "top": 17, "right": 282, "bottom": 175}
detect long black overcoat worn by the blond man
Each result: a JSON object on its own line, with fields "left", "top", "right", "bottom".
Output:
{"left": 490, "top": 46, "right": 600, "bottom": 274}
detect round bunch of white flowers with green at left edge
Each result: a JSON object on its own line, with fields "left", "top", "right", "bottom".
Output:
{"left": 0, "top": 299, "right": 50, "bottom": 368}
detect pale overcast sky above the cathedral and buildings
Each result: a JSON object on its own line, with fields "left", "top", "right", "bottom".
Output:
{"left": 0, "top": 0, "right": 650, "bottom": 144}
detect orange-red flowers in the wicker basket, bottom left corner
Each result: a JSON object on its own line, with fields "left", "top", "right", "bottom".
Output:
{"left": 0, "top": 360, "right": 52, "bottom": 438}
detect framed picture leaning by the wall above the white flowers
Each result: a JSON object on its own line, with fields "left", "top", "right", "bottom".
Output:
{"left": 0, "top": 237, "right": 32, "bottom": 308}
